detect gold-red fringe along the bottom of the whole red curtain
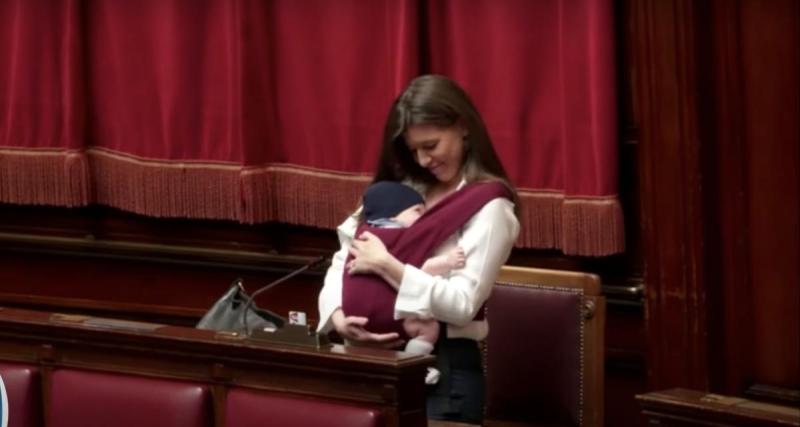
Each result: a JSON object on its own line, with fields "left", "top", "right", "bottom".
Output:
{"left": 0, "top": 149, "right": 625, "bottom": 256}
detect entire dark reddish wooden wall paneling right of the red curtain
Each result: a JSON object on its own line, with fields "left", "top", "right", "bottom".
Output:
{"left": 624, "top": 0, "right": 800, "bottom": 402}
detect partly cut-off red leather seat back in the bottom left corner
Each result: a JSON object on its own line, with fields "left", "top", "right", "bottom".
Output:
{"left": 0, "top": 362, "right": 42, "bottom": 427}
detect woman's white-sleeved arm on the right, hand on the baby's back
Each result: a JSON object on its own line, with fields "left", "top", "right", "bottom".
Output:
{"left": 348, "top": 199, "right": 519, "bottom": 325}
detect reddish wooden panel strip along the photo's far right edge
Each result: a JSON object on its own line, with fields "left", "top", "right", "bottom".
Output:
{"left": 728, "top": 0, "right": 800, "bottom": 388}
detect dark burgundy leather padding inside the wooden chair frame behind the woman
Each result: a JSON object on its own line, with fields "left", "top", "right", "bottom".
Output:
{"left": 487, "top": 286, "right": 581, "bottom": 425}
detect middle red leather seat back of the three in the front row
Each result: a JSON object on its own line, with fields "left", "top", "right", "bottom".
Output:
{"left": 47, "top": 369, "right": 213, "bottom": 427}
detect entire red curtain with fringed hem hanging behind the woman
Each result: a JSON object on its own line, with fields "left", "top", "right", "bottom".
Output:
{"left": 0, "top": 0, "right": 623, "bottom": 255}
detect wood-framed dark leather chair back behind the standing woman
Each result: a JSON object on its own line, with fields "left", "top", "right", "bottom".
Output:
{"left": 484, "top": 266, "right": 605, "bottom": 426}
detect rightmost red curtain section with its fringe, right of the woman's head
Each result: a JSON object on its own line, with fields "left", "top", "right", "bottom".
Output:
{"left": 428, "top": 0, "right": 624, "bottom": 255}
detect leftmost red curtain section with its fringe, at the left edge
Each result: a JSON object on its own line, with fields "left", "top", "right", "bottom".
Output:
{"left": 0, "top": 0, "right": 90, "bottom": 206}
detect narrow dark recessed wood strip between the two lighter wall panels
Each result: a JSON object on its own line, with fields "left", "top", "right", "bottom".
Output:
{"left": 704, "top": 1, "right": 754, "bottom": 394}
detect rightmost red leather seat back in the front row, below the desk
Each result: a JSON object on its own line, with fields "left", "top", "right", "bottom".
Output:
{"left": 225, "top": 389, "right": 381, "bottom": 427}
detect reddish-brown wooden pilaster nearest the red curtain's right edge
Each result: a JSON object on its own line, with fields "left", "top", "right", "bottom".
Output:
{"left": 627, "top": 0, "right": 707, "bottom": 388}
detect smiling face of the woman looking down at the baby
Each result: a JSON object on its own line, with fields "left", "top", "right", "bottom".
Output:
{"left": 403, "top": 125, "right": 466, "bottom": 189}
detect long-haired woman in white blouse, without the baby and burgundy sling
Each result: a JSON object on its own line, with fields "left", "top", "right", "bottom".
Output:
{"left": 319, "top": 75, "right": 519, "bottom": 423}
